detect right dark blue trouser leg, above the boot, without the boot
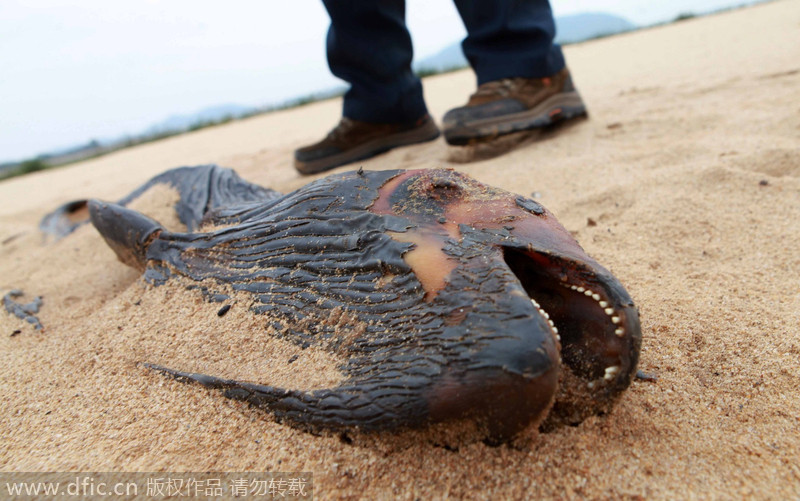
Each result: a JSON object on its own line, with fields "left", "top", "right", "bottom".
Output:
{"left": 455, "top": 0, "right": 564, "bottom": 85}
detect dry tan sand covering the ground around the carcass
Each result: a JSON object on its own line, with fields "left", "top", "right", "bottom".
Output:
{"left": 0, "top": 0, "right": 800, "bottom": 499}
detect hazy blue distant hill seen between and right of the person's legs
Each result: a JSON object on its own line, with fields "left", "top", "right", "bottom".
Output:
{"left": 414, "top": 12, "right": 637, "bottom": 71}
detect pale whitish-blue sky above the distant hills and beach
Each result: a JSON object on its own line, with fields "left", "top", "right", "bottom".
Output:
{"left": 0, "top": 0, "right": 755, "bottom": 163}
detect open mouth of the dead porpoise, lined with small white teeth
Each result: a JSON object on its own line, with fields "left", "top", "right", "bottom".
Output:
{"left": 503, "top": 247, "right": 641, "bottom": 424}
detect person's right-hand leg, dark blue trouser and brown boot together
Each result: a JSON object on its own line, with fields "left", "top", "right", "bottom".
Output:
{"left": 442, "top": 0, "right": 586, "bottom": 145}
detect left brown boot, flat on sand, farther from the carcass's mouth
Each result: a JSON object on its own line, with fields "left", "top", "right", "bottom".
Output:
{"left": 294, "top": 115, "right": 439, "bottom": 174}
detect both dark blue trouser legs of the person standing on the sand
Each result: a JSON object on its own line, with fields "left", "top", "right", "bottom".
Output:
{"left": 323, "top": 0, "right": 564, "bottom": 123}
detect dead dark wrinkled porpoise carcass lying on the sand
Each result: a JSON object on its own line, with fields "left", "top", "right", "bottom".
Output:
{"left": 49, "top": 166, "right": 641, "bottom": 443}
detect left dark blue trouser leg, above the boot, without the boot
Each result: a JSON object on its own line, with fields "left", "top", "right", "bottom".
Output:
{"left": 323, "top": 0, "right": 428, "bottom": 124}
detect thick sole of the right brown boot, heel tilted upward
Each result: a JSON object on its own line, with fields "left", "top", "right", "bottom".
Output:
{"left": 444, "top": 92, "right": 587, "bottom": 146}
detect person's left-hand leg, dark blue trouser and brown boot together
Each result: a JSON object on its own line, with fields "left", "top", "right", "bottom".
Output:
{"left": 294, "top": 0, "right": 439, "bottom": 174}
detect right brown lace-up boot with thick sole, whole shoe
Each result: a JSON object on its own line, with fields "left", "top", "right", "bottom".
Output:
{"left": 442, "top": 68, "right": 586, "bottom": 146}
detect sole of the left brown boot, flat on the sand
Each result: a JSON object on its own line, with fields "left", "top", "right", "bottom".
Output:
{"left": 294, "top": 120, "right": 440, "bottom": 175}
